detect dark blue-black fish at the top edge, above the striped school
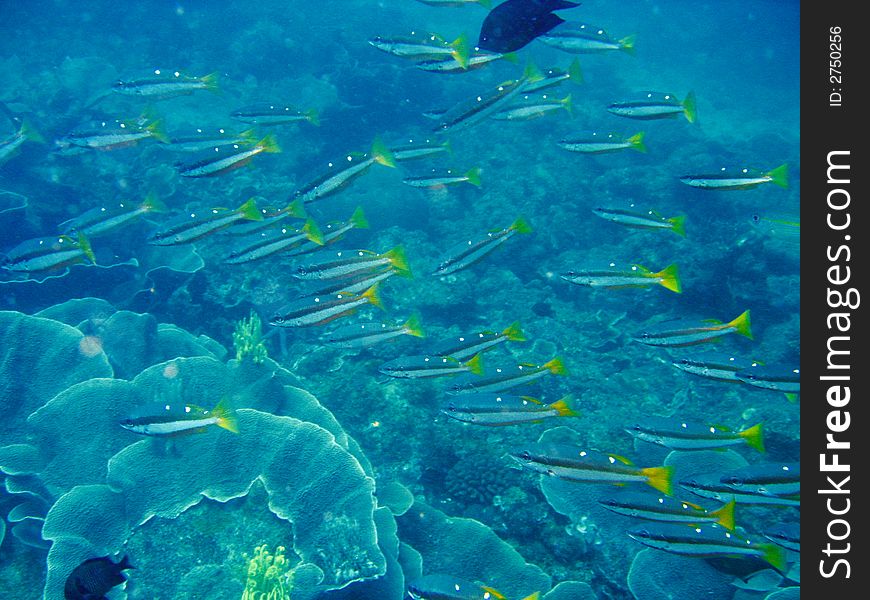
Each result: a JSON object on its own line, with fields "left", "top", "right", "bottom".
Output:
{"left": 477, "top": 0, "right": 580, "bottom": 53}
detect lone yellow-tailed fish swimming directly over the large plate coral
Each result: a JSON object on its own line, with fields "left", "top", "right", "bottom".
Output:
{"left": 120, "top": 400, "right": 239, "bottom": 437}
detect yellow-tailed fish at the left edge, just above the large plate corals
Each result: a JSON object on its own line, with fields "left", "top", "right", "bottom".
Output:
{"left": 0, "top": 233, "right": 97, "bottom": 274}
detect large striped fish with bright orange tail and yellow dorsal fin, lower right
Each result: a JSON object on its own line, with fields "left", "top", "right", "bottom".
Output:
{"left": 510, "top": 443, "right": 674, "bottom": 496}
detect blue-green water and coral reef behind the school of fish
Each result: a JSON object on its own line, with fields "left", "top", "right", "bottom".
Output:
{"left": 0, "top": 0, "right": 800, "bottom": 600}
